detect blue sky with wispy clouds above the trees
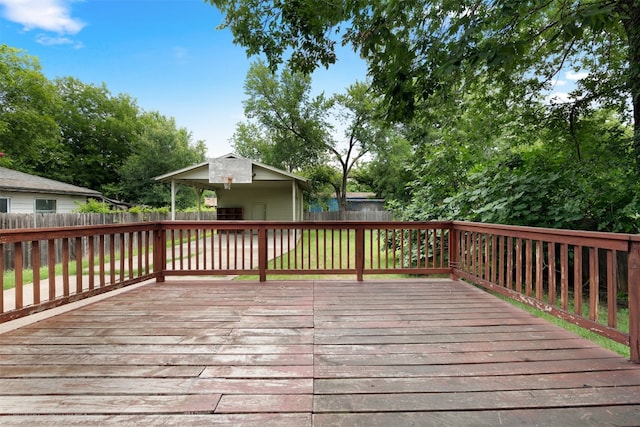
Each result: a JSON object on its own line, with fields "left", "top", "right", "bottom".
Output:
{"left": 0, "top": 0, "right": 366, "bottom": 157}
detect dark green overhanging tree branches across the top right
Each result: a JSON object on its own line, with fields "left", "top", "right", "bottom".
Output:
{"left": 208, "top": 0, "right": 640, "bottom": 171}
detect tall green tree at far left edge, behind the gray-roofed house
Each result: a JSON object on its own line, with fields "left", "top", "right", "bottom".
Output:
{"left": 0, "top": 45, "right": 62, "bottom": 177}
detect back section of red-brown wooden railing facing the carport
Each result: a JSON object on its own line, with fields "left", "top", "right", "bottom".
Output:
{"left": 157, "top": 221, "right": 451, "bottom": 281}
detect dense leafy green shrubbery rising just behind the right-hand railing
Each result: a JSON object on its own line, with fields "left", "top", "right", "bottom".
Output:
{"left": 395, "top": 102, "right": 640, "bottom": 233}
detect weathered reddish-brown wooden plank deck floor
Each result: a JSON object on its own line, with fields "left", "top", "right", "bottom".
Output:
{"left": 0, "top": 279, "right": 640, "bottom": 427}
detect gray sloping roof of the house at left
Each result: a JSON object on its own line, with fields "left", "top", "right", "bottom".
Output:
{"left": 0, "top": 167, "right": 102, "bottom": 197}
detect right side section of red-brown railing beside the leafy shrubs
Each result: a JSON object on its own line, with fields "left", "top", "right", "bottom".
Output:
{"left": 451, "top": 222, "right": 640, "bottom": 362}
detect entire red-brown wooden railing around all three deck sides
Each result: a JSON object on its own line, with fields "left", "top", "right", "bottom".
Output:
{"left": 0, "top": 221, "right": 640, "bottom": 362}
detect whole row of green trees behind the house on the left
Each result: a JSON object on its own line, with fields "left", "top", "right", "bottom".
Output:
{"left": 0, "top": 45, "right": 206, "bottom": 211}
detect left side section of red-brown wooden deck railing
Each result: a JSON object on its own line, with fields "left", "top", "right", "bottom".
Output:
{"left": 0, "top": 223, "right": 162, "bottom": 322}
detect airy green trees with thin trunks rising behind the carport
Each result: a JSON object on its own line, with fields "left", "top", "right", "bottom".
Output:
{"left": 232, "top": 62, "right": 389, "bottom": 209}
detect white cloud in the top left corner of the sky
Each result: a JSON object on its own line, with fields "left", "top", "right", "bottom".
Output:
{"left": 0, "top": 0, "right": 85, "bottom": 34}
